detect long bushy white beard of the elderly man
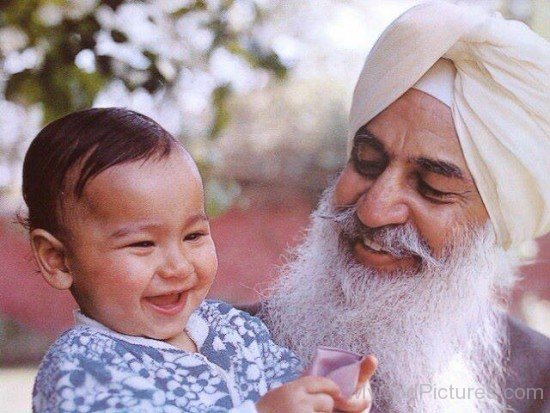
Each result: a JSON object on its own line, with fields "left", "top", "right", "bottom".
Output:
{"left": 262, "top": 187, "right": 515, "bottom": 413}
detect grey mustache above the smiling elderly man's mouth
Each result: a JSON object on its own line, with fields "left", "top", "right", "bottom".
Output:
{"left": 322, "top": 205, "right": 440, "bottom": 265}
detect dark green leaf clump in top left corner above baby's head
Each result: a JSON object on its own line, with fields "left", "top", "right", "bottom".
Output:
{"left": 2, "top": 0, "right": 110, "bottom": 122}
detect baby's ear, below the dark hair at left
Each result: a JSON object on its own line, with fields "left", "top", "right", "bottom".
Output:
{"left": 30, "top": 228, "right": 73, "bottom": 290}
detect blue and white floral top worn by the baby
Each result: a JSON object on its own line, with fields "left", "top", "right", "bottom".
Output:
{"left": 33, "top": 300, "right": 302, "bottom": 413}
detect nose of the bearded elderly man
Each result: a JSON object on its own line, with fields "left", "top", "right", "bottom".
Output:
{"left": 357, "top": 169, "right": 410, "bottom": 228}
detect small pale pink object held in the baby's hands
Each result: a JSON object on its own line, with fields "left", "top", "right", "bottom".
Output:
{"left": 303, "top": 346, "right": 363, "bottom": 398}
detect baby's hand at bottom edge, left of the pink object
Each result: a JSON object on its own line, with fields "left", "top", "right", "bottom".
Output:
{"left": 256, "top": 376, "right": 342, "bottom": 413}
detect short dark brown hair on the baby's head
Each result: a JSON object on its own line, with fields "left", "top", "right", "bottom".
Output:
{"left": 19, "top": 108, "right": 179, "bottom": 236}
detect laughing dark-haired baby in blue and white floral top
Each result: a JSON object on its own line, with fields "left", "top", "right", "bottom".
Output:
{"left": 23, "top": 108, "right": 375, "bottom": 413}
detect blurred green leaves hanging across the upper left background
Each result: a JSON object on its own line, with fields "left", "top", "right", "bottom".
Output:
{"left": 0, "top": 0, "right": 287, "bottom": 130}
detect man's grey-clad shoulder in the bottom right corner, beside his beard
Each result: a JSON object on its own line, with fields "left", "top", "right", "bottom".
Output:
{"left": 505, "top": 316, "right": 550, "bottom": 412}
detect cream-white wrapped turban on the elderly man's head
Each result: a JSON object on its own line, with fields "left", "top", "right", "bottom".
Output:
{"left": 349, "top": 1, "right": 550, "bottom": 249}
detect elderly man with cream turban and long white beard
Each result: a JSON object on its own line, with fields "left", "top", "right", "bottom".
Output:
{"left": 261, "top": 2, "right": 550, "bottom": 413}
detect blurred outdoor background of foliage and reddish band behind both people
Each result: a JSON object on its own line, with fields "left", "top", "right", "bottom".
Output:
{"left": 0, "top": 0, "right": 550, "bottom": 412}
